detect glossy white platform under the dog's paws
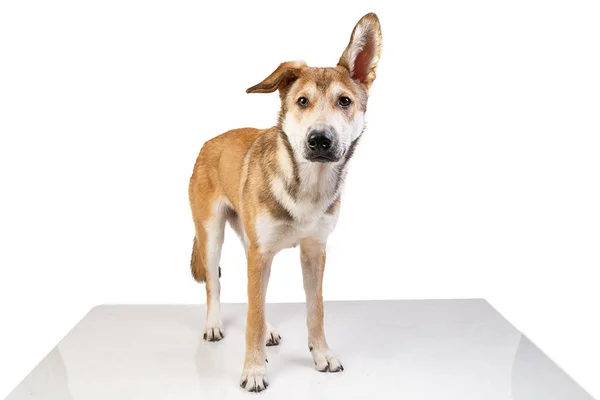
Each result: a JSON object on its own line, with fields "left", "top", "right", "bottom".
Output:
{"left": 7, "top": 300, "right": 593, "bottom": 400}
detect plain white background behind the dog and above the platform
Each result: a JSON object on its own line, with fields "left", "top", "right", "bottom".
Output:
{"left": 0, "top": 0, "right": 600, "bottom": 397}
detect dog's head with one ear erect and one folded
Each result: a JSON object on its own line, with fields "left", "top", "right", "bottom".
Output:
{"left": 246, "top": 13, "right": 382, "bottom": 162}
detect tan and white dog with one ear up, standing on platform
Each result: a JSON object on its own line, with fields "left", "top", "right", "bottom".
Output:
{"left": 189, "top": 13, "right": 382, "bottom": 392}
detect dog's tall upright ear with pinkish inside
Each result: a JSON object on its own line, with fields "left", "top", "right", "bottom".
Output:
{"left": 338, "top": 13, "right": 382, "bottom": 88}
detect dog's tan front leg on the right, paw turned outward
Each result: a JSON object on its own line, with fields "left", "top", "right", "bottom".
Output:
{"left": 300, "top": 239, "right": 344, "bottom": 372}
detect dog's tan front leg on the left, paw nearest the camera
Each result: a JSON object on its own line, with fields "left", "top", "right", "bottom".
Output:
{"left": 240, "top": 245, "right": 273, "bottom": 392}
